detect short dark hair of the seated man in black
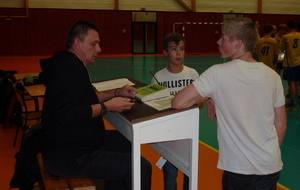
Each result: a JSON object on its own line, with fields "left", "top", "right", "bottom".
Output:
{"left": 66, "top": 20, "right": 99, "bottom": 49}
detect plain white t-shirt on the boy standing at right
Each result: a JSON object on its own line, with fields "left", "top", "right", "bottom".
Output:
{"left": 193, "top": 60, "right": 285, "bottom": 175}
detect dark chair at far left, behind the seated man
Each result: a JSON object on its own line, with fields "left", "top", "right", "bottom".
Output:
{"left": 14, "top": 89, "right": 42, "bottom": 146}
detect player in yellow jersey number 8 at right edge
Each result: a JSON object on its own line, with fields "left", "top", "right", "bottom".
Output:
{"left": 280, "top": 20, "right": 300, "bottom": 111}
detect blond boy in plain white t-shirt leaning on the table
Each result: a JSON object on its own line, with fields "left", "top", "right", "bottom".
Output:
{"left": 172, "top": 18, "right": 286, "bottom": 190}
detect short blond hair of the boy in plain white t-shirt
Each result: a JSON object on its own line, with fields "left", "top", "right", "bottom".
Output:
{"left": 222, "top": 17, "right": 259, "bottom": 52}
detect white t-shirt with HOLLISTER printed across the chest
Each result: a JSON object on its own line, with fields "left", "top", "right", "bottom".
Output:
{"left": 151, "top": 66, "right": 199, "bottom": 95}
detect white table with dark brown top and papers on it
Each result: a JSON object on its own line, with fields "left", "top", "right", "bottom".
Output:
{"left": 104, "top": 106, "right": 199, "bottom": 190}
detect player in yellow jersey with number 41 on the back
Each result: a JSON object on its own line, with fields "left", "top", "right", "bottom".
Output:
{"left": 255, "top": 24, "right": 279, "bottom": 71}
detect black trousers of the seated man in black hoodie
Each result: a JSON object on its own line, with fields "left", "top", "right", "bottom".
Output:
{"left": 44, "top": 130, "right": 152, "bottom": 190}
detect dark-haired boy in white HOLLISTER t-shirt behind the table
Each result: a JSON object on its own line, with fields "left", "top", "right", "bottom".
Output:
{"left": 151, "top": 33, "right": 203, "bottom": 190}
